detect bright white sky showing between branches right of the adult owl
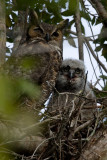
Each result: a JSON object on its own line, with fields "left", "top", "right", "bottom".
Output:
{"left": 63, "top": 2, "right": 107, "bottom": 89}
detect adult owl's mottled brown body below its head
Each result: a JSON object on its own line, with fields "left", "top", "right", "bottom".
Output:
{"left": 3, "top": 40, "right": 62, "bottom": 109}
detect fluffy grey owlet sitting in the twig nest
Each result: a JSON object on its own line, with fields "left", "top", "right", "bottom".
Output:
{"left": 48, "top": 59, "right": 95, "bottom": 119}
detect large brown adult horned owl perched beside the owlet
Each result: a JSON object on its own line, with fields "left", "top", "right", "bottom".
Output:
{"left": 3, "top": 12, "right": 68, "bottom": 109}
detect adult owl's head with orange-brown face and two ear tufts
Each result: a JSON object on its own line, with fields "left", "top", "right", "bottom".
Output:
{"left": 28, "top": 11, "right": 68, "bottom": 48}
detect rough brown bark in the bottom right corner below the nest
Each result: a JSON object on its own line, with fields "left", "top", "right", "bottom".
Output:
{"left": 79, "top": 129, "right": 107, "bottom": 160}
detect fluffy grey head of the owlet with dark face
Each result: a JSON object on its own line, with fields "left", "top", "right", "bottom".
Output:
{"left": 56, "top": 59, "right": 85, "bottom": 92}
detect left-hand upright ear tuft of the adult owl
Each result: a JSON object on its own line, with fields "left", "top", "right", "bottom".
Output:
{"left": 30, "top": 9, "right": 40, "bottom": 26}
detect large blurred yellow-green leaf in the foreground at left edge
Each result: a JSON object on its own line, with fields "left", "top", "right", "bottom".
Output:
{"left": 0, "top": 75, "right": 41, "bottom": 115}
